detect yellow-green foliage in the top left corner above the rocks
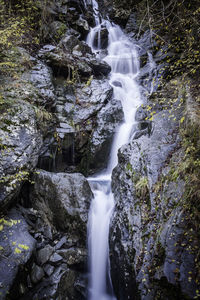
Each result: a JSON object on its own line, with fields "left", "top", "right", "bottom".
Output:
{"left": 0, "top": 0, "right": 57, "bottom": 76}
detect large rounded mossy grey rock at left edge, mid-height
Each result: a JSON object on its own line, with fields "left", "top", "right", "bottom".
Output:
{"left": 0, "top": 100, "right": 42, "bottom": 208}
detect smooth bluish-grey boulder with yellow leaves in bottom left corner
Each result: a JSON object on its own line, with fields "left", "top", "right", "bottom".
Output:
{"left": 0, "top": 209, "right": 35, "bottom": 299}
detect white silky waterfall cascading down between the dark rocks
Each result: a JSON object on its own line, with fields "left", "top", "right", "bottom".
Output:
{"left": 87, "top": 0, "right": 141, "bottom": 300}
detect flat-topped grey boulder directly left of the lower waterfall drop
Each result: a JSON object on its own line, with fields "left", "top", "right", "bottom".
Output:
{"left": 31, "top": 170, "right": 92, "bottom": 244}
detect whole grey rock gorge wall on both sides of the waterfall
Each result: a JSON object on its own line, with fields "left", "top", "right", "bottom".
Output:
{"left": 0, "top": 0, "right": 200, "bottom": 300}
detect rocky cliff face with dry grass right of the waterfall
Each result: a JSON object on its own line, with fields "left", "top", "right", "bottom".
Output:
{"left": 110, "top": 5, "right": 199, "bottom": 299}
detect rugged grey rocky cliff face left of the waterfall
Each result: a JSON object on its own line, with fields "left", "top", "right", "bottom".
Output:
{"left": 0, "top": 1, "right": 114, "bottom": 299}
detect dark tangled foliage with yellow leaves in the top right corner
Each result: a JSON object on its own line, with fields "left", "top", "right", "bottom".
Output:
{"left": 136, "top": 0, "right": 200, "bottom": 96}
